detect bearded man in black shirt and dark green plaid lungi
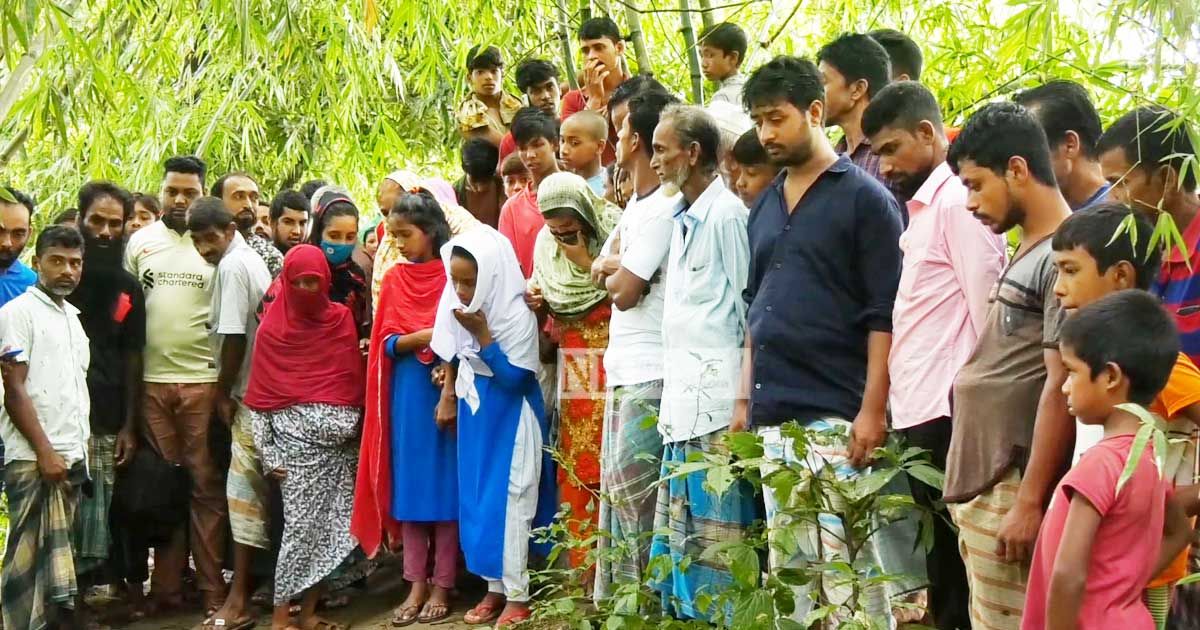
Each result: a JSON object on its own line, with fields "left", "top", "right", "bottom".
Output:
{"left": 67, "top": 181, "right": 146, "bottom": 602}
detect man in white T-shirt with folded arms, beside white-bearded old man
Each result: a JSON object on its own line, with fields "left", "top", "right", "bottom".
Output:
{"left": 593, "top": 84, "right": 679, "bottom": 600}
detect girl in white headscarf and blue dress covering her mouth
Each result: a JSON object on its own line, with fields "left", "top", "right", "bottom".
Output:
{"left": 432, "top": 226, "right": 554, "bottom": 628}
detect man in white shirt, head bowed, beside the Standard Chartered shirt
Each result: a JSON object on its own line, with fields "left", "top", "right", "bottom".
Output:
{"left": 187, "top": 197, "right": 271, "bottom": 628}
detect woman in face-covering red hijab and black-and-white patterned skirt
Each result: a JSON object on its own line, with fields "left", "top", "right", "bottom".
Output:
{"left": 245, "top": 245, "right": 364, "bottom": 630}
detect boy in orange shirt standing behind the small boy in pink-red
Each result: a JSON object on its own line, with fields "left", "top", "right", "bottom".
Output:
{"left": 1051, "top": 203, "right": 1200, "bottom": 628}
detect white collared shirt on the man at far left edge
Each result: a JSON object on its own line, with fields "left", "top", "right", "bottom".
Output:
{"left": 0, "top": 284, "right": 91, "bottom": 464}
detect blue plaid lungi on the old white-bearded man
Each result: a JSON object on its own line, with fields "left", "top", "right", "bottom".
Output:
{"left": 650, "top": 428, "right": 757, "bottom": 619}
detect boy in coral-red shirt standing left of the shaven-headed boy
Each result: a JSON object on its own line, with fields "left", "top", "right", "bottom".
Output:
{"left": 497, "top": 107, "right": 558, "bottom": 278}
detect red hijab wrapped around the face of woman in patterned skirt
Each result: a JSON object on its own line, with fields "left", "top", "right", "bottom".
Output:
{"left": 245, "top": 245, "right": 364, "bottom": 412}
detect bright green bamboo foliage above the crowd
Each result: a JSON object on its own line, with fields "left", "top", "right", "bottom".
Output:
{"left": 0, "top": 0, "right": 1200, "bottom": 221}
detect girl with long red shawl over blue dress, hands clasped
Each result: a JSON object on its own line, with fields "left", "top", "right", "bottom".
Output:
{"left": 350, "top": 192, "right": 458, "bottom": 628}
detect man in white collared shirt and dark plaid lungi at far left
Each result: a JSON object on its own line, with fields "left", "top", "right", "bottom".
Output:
{"left": 0, "top": 226, "right": 91, "bottom": 629}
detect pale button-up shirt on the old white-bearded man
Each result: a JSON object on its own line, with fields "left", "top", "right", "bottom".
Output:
{"left": 659, "top": 178, "right": 750, "bottom": 442}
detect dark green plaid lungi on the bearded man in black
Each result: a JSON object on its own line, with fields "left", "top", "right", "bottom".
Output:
{"left": 74, "top": 433, "right": 116, "bottom": 575}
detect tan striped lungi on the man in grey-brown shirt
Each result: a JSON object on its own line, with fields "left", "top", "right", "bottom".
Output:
{"left": 947, "top": 468, "right": 1030, "bottom": 630}
